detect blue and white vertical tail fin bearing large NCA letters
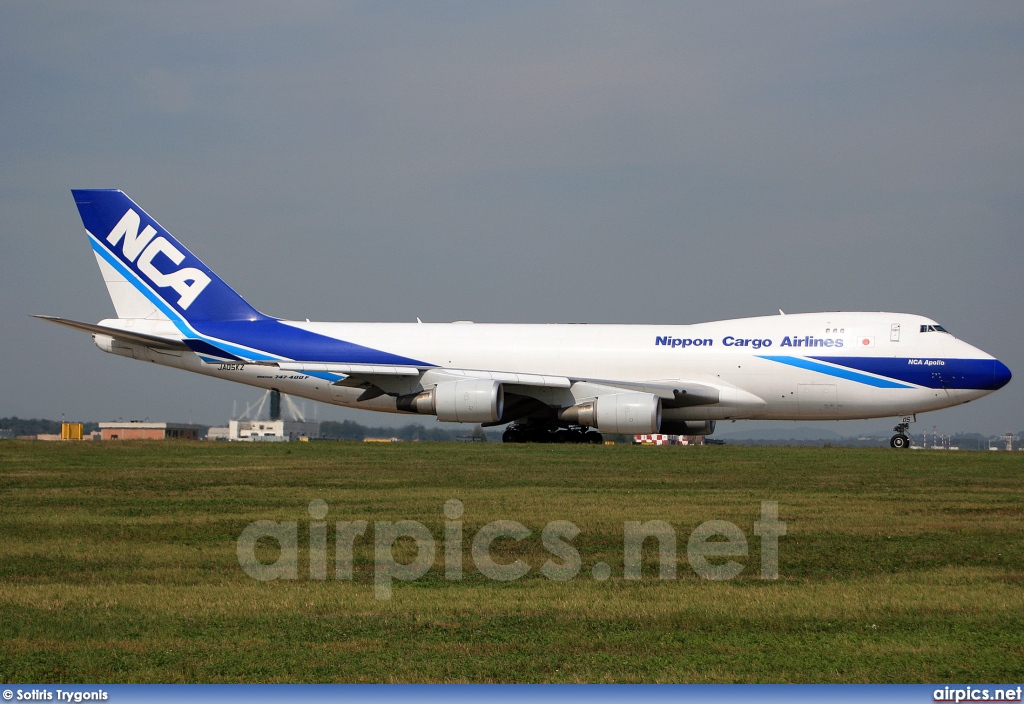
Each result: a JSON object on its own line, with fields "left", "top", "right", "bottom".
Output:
{"left": 72, "top": 189, "right": 266, "bottom": 321}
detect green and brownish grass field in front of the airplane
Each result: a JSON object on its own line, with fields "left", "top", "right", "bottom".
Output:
{"left": 0, "top": 441, "right": 1024, "bottom": 684}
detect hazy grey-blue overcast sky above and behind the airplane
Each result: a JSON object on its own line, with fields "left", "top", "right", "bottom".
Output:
{"left": 0, "top": 0, "right": 1024, "bottom": 433}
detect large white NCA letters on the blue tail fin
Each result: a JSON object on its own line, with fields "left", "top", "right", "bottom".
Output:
{"left": 106, "top": 209, "right": 210, "bottom": 310}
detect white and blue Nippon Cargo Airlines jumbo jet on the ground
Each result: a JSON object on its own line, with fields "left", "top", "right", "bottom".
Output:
{"left": 37, "top": 189, "right": 1011, "bottom": 448}
